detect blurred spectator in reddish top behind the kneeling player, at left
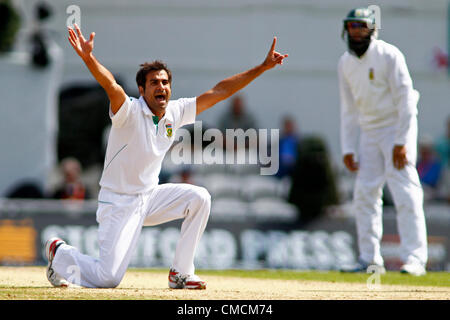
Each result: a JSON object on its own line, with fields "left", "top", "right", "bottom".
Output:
{"left": 53, "top": 158, "right": 90, "bottom": 200}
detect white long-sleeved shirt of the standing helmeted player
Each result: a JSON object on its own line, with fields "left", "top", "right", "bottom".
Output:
{"left": 338, "top": 38, "right": 419, "bottom": 154}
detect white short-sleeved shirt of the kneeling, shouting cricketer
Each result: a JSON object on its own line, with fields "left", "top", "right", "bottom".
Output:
{"left": 100, "top": 96, "right": 197, "bottom": 194}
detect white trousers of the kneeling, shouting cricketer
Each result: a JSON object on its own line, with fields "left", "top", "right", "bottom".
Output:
{"left": 53, "top": 183, "right": 211, "bottom": 288}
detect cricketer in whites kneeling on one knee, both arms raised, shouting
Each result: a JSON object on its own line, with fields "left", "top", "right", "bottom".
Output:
{"left": 45, "top": 25, "right": 287, "bottom": 289}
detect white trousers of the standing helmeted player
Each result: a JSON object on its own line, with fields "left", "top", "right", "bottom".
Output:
{"left": 354, "top": 122, "right": 428, "bottom": 267}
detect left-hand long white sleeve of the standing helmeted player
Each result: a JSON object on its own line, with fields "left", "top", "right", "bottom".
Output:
{"left": 338, "top": 60, "right": 359, "bottom": 155}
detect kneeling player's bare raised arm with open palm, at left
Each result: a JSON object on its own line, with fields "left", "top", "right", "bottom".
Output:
{"left": 68, "top": 24, "right": 127, "bottom": 114}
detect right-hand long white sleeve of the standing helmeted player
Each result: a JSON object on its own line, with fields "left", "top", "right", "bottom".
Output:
{"left": 388, "top": 48, "right": 420, "bottom": 145}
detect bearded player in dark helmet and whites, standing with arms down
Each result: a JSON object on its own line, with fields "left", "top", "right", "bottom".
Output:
{"left": 338, "top": 8, "right": 427, "bottom": 276}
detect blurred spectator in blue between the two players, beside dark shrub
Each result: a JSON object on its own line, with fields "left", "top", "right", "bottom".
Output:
{"left": 277, "top": 116, "right": 300, "bottom": 178}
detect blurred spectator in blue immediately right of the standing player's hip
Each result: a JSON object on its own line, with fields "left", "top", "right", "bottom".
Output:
{"left": 417, "top": 136, "right": 442, "bottom": 200}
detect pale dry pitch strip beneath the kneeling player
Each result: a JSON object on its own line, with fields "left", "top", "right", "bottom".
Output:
{"left": 0, "top": 267, "right": 450, "bottom": 300}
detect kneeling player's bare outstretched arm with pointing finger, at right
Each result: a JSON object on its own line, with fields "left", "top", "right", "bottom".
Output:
{"left": 197, "top": 37, "right": 288, "bottom": 114}
